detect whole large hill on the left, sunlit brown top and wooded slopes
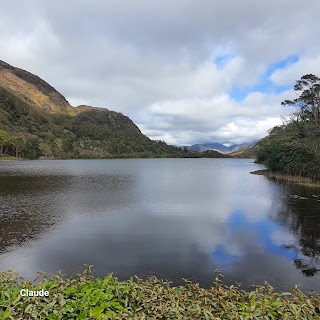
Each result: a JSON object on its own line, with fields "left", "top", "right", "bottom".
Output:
{"left": 0, "top": 61, "right": 225, "bottom": 159}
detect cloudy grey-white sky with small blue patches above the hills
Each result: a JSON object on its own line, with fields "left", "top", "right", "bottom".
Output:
{"left": 0, "top": 0, "right": 320, "bottom": 146}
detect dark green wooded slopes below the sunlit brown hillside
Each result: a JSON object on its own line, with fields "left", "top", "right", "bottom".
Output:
{"left": 0, "top": 87, "right": 226, "bottom": 159}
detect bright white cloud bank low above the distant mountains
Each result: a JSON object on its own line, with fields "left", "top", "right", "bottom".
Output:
{"left": 139, "top": 91, "right": 293, "bottom": 145}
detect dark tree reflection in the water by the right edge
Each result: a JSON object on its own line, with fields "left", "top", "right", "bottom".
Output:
{"left": 276, "top": 187, "right": 320, "bottom": 277}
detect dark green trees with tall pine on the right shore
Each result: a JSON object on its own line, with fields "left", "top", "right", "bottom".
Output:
{"left": 257, "top": 74, "right": 320, "bottom": 183}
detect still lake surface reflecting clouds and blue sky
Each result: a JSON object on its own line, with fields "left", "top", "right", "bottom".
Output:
{"left": 0, "top": 159, "right": 320, "bottom": 292}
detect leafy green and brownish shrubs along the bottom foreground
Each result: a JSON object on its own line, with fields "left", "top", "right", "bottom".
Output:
{"left": 0, "top": 269, "right": 320, "bottom": 319}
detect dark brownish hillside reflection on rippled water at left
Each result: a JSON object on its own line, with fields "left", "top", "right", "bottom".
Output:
{"left": 0, "top": 173, "right": 134, "bottom": 253}
